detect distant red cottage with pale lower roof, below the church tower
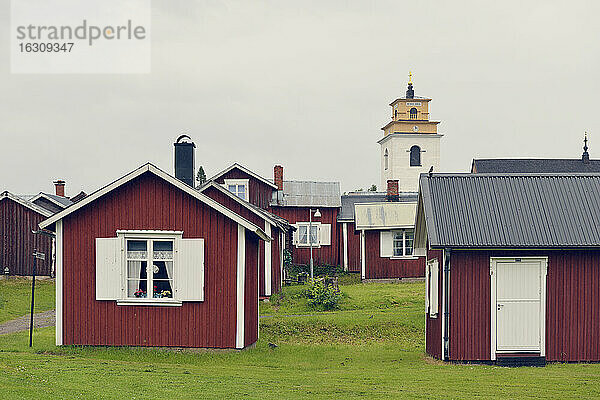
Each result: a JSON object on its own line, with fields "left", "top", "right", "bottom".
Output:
{"left": 338, "top": 180, "right": 425, "bottom": 279}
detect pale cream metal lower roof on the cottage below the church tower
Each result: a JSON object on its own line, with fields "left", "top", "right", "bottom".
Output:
{"left": 354, "top": 202, "right": 417, "bottom": 230}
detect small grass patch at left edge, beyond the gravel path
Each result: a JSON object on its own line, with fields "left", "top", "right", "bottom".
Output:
{"left": 0, "top": 278, "right": 55, "bottom": 323}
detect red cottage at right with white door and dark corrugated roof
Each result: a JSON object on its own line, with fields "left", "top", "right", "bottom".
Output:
{"left": 415, "top": 174, "right": 600, "bottom": 363}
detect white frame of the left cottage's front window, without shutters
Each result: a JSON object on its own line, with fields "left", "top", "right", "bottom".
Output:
{"left": 117, "top": 230, "right": 183, "bottom": 306}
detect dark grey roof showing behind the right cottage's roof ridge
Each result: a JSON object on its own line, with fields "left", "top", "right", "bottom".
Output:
{"left": 471, "top": 158, "right": 600, "bottom": 173}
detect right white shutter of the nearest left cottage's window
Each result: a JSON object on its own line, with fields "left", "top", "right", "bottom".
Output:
{"left": 175, "top": 239, "right": 204, "bottom": 301}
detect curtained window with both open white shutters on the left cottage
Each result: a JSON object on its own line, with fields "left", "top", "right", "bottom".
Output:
{"left": 96, "top": 231, "right": 204, "bottom": 305}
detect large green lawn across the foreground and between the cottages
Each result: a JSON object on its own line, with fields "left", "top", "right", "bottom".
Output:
{"left": 0, "top": 276, "right": 600, "bottom": 399}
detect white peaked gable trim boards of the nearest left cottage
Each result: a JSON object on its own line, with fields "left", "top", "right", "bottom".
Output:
{"left": 40, "top": 163, "right": 271, "bottom": 241}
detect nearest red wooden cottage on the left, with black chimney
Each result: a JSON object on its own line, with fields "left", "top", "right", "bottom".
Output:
{"left": 40, "top": 162, "right": 269, "bottom": 348}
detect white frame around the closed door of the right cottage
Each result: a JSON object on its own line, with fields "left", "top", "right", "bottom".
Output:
{"left": 489, "top": 256, "right": 548, "bottom": 360}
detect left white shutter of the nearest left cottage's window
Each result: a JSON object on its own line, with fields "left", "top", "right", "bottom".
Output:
{"left": 96, "top": 238, "right": 120, "bottom": 300}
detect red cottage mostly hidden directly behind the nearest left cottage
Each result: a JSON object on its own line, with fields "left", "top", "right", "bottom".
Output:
{"left": 199, "top": 181, "right": 291, "bottom": 297}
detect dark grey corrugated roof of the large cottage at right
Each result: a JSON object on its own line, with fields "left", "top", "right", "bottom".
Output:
{"left": 415, "top": 174, "right": 600, "bottom": 248}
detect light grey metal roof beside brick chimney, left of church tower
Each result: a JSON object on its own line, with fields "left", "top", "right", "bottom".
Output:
{"left": 273, "top": 181, "right": 342, "bottom": 207}
